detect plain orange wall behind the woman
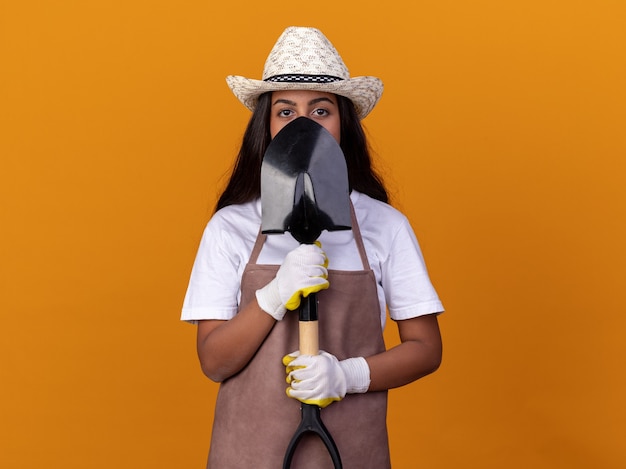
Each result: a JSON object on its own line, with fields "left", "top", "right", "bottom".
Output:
{"left": 0, "top": 0, "right": 626, "bottom": 469}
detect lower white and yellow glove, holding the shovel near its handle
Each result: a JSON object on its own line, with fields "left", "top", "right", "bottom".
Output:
{"left": 283, "top": 351, "right": 370, "bottom": 408}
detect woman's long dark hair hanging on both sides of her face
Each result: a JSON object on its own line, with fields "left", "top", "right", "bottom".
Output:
{"left": 215, "top": 93, "right": 388, "bottom": 211}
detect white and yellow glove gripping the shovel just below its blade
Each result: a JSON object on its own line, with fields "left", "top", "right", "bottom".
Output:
{"left": 256, "top": 241, "right": 328, "bottom": 321}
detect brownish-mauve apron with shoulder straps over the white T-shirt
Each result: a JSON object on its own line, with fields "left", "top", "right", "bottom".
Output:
{"left": 207, "top": 209, "right": 391, "bottom": 469}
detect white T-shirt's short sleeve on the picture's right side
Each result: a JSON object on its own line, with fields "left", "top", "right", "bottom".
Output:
{"left": 381, "top": 218, "right": 444, "bottom": 321}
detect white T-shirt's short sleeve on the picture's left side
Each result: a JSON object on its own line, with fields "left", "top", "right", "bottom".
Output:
{"left": 181, "top": 220, "right": 241, "bottom": 324}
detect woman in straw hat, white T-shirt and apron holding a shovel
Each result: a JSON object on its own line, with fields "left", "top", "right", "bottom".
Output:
{"left": 182, "top": 27, "right": 443, "bottom": 469}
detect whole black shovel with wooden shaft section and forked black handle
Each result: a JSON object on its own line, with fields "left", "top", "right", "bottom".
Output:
{"left": 261, "top": 117, "right": 351, "bottom": 469}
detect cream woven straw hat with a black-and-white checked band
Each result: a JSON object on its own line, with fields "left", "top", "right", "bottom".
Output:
{"left": 226, "top": 26, "right": 383, "bottom": 119}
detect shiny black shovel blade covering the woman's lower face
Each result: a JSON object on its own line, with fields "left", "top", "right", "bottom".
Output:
{"left": 261, "top": 117, "right": 351, "bottom": 244}
